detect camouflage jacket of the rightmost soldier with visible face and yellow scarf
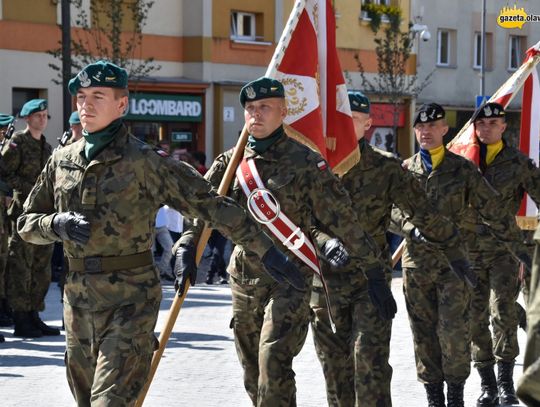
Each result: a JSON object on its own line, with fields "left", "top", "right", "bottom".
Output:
{"left": 467, "top": 143, "right": 540, "bottom": 251}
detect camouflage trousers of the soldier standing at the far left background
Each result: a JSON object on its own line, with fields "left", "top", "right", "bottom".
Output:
{"left": 6, "top": 225, "right": 53, "bottom": 311}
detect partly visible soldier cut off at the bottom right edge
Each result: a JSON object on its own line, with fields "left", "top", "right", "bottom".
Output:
{"left": 517, "top": 222, "right": 540, "bottom": 407}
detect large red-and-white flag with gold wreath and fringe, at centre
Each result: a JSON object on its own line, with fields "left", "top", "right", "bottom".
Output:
{"left": 266, "top": 0, "right": 360, "bottom": 174}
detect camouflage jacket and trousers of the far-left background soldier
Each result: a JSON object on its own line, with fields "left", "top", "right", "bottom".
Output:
{"left": 0, "top": 131, "right": 52, "bottom": 311}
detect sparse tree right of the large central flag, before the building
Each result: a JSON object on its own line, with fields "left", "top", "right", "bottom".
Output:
{"left": 355, "top": 3, "right": 433, "bottom": 151}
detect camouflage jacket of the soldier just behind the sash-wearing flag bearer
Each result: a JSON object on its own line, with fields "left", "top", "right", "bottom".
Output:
{"left": 317, "top": 143, "right": 467, "bottom": 268}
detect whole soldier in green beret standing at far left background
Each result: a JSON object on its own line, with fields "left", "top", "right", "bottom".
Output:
{"left": 0, "top": 99, "right": 60, "bottom": 338}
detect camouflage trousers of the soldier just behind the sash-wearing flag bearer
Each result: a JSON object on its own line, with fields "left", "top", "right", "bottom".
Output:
{"left": 310, "top": 279, "right": 392, "bottom": 407}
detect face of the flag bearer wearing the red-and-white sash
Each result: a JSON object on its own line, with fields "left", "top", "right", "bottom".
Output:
{"left": 244, "top": 98, "right": 287, "bottom": 138}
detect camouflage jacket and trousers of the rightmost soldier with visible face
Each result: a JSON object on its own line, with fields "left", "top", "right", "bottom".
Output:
{"left": 470, "top": 143, "right": 540, "bottom": 368}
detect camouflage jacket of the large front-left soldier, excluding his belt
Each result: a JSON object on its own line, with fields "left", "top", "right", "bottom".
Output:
{"left": 17, "top": 126, "right": 272, "bottom": 309}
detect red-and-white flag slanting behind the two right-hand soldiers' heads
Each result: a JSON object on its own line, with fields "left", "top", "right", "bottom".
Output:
{"left": 447, "top": 42, "right": 540, "bottom": 165}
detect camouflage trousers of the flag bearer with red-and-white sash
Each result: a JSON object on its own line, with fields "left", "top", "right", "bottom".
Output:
{"left": 230, "top": 277, "right": 310, "bottom": 407}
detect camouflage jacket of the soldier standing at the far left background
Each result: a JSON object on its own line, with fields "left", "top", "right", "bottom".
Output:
{"left": 0, "top": 131, "right": 52, "bottom": 219}
